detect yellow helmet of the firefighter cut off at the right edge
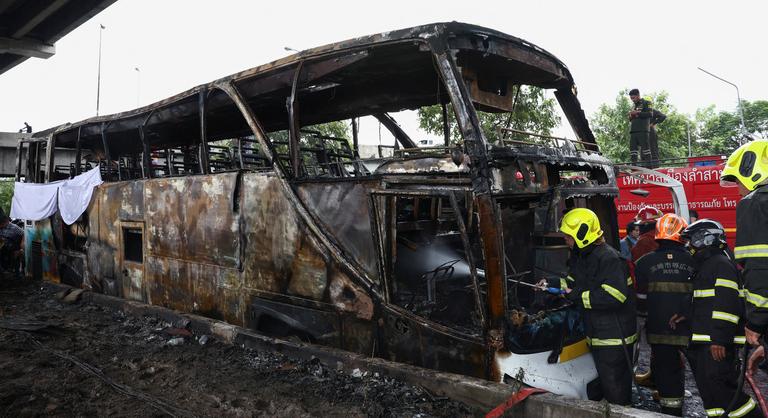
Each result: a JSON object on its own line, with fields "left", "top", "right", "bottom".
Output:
{"left": 720, "top": 141, "right": 768, "bottom": 190}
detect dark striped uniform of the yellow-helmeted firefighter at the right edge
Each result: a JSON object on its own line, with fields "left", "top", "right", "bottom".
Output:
{"left": 734, "top": 186, "right": 768, "bottom": 335}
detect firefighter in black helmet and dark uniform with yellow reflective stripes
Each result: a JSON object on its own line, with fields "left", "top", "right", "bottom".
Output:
{"left": 682, "top": 219, "right": 762, "bottom": 417}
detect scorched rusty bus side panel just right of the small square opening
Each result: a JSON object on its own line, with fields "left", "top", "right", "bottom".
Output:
{"left": 144, "top": 173, "right": 243, "bottom": 318}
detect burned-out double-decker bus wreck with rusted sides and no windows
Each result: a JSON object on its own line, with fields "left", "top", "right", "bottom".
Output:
{"left": 17, "top": 22, "right": 617, "bottom": 398}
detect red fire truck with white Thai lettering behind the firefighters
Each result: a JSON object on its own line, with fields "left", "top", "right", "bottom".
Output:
{"left": 616, "top": 156, "right": 740, "bottom": 248}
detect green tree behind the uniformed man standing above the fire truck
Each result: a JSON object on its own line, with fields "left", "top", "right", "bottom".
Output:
{"left": 590, "top": 90, "right": 695, "bottom": 162}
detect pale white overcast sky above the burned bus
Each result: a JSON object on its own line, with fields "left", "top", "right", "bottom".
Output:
{"left": 0, "top": 0, "right": 768, "bottom": 145}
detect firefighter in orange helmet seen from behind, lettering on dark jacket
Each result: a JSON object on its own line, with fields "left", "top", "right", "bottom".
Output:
{"left": 635, "top": 213, "right": 694, "bottom": 416}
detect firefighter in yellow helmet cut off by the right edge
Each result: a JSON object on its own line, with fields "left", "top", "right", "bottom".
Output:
{"left": 720, "top": 141, "right": 768, "bottom": 345}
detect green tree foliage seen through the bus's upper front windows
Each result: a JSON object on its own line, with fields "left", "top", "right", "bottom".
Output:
{"left": 418, "top": 86, "right": 560, "bottom": 143}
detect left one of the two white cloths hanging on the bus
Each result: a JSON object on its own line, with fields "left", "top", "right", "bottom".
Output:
{"left": 11, "top": 180, "right": 64, "bottom": 221}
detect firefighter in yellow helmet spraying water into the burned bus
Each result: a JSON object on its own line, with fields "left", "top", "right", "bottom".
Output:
{"left": 560, "top": 208, "right": 637, "bottom": 405}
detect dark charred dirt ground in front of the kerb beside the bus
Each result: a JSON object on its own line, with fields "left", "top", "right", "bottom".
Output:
{"left": 0, "top": 279, "right": 478, "bottom": 417}
